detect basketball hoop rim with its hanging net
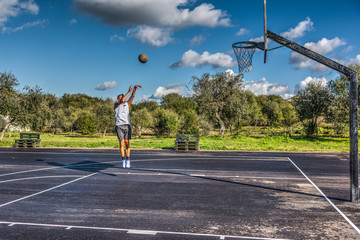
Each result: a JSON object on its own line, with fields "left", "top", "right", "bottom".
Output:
{"left": 232, "top": 41, "right": 264, "bottom": 74}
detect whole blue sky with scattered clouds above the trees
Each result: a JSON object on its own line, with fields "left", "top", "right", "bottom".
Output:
{"left": 0, "top": 0, "right": 360, "bottom": 102}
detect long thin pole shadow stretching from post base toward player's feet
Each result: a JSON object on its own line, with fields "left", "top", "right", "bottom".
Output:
{"left": 128, "top": 168, "right": 350, "bottom": 202}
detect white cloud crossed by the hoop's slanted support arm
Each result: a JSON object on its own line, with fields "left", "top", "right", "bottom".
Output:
{"left": 290, "top": 37, "right": 346, "bottom": 72}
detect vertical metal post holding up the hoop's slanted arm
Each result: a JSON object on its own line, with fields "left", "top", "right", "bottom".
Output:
{"left": 349, "top": 72, "right": 359, "bottom": 202}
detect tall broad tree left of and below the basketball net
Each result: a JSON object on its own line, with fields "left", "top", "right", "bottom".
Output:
{"left": 192, "top": 72, "right": 246, "bottom": 137}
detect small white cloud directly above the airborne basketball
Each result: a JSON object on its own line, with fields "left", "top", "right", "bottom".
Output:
{"left": 127, "top": 25, "right": 173, "bottom": 47}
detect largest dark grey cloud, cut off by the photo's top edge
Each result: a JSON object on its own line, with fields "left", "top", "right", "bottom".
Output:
{"left": 74, "top": 0, "right": 231, "bottom": 28}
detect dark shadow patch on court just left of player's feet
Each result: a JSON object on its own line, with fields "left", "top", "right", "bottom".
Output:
{"left": 48, "top": 161, "right": 116, "bottom": 176}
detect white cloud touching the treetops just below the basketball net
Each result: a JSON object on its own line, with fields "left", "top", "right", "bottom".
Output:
{"left": 243, "top": 78, "right": 294, "bottom": 99}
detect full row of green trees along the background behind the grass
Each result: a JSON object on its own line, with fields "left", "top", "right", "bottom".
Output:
{"left": 0, "top": 65, "right": 360, "bottom": 140}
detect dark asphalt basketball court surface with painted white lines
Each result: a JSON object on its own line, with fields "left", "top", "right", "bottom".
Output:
{"left": 0, "top": 148, "right": 360, "bottom": 240}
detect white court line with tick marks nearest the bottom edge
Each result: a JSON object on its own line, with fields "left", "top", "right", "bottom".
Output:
{"left": 0, "top": 221, "right": 288, "bottom": 240}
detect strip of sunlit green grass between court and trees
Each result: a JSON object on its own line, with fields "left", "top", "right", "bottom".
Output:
{"left": 0, "top": 132, "right": 349, "bottom": 152}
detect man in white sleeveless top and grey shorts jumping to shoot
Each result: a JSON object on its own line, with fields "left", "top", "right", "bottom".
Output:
{"left": 114, "top": 85, "right": 141, "bottom": 168}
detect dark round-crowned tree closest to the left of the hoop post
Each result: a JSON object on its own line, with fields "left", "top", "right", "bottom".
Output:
{"left": 294, "top": 82, "right": 332, "bottom": 136}
